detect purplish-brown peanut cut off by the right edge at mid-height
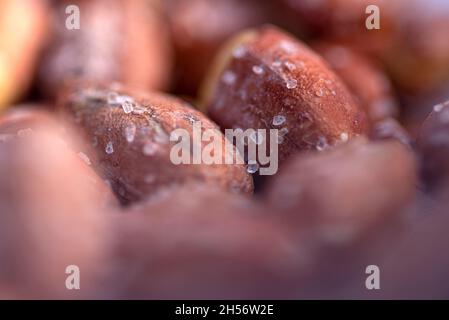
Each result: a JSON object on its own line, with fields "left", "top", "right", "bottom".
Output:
{"left": 417, "top": 101, "right": 449, "bottom": 191}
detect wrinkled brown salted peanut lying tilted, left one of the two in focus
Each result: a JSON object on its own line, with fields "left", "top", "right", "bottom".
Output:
{"left": 60, "top": 86, "right": 253, "bottom": 203}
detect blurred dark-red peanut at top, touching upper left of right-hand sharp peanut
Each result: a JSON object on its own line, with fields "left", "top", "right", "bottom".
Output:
{"left": 164, "top": 0, "right": 267, "bottom": 96}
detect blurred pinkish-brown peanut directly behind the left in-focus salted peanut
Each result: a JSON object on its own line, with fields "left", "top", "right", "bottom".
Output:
{"left": 39, "top": 0, "right": 171, "bottom": 97}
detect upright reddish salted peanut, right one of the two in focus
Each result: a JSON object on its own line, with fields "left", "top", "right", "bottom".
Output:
{"left": 202, "top": 26, "right": 365, "bottom": 161}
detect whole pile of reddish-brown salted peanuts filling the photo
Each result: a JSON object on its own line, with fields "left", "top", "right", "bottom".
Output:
{"left": 0, "top": 0, "right": 449, "bottom": 299}
